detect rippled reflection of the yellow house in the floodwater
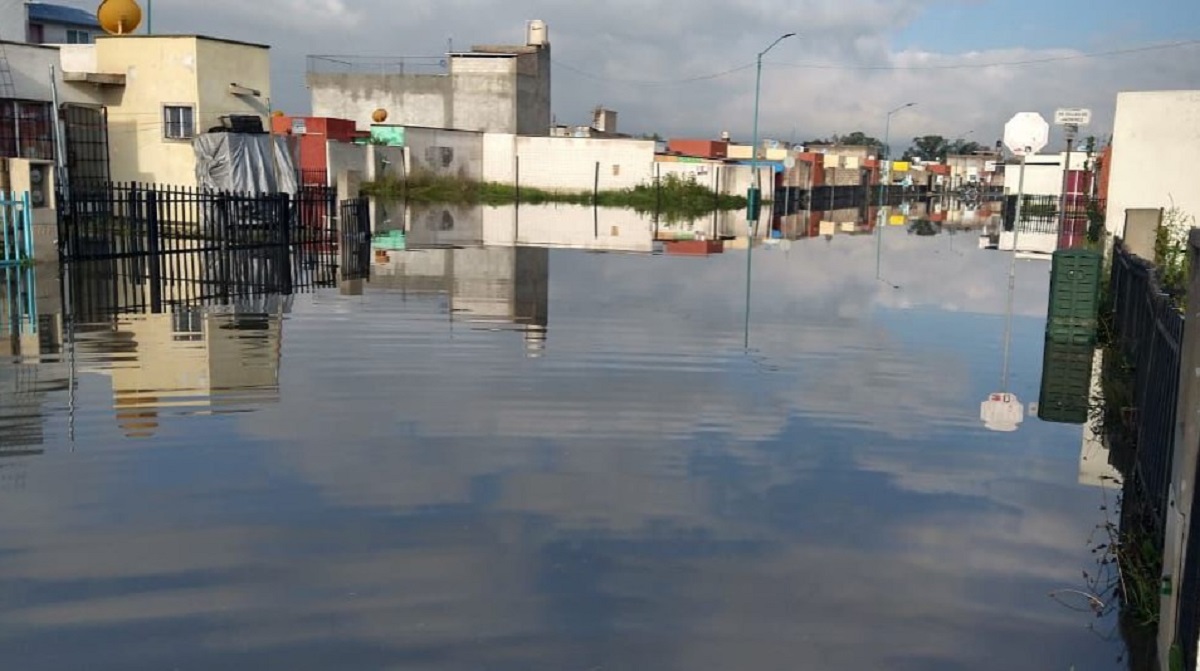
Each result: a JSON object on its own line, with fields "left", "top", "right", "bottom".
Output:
{"left": 109, "top": 308, "right": 282, "bottom": 437}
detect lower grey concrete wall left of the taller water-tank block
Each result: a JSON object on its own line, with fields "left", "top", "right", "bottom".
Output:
{"left": 307, "top": 72, "right": 454, "bottom": 128}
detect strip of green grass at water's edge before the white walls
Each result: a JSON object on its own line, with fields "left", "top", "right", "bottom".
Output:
{"left": 362, "top": 170, "right": 746, "bottom": 218}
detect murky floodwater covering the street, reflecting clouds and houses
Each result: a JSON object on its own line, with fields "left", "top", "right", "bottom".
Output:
{"left": 0, "top": 201, "right": 1123, "bottom": 671}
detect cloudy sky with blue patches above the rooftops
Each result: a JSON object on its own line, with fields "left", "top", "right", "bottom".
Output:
{"left": 65, "top": 0, "right": 1200, "bottom": 149}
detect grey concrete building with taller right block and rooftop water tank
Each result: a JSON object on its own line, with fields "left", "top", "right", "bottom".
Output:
{"left": 307, "top": 20, "right": 551, "bottom": 136}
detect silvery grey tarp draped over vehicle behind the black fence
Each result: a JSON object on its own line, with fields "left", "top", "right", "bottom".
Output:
{"left": 192, "top": 133, "right": 296, "bottom": 194}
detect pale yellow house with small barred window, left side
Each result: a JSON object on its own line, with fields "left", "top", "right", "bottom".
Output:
{"left": 61, "top": 35, "right": 271, "bottom": 186}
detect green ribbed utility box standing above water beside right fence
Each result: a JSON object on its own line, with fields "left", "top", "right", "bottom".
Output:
{"left": 1046, "top": 250, "right": 1104, "bottom": 345}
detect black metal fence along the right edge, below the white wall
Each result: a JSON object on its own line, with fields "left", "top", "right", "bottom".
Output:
{"left": 1111, "top": 240, "right": 1183, "bottom": 535}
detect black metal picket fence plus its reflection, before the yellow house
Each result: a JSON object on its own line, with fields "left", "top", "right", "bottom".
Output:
{"left": 59, "top": 184, "right": 371, "bottom": 314}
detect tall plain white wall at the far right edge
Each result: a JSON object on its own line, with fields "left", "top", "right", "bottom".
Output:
{"left": 1108, "top": 91, "right": 1200, "bottom": 235}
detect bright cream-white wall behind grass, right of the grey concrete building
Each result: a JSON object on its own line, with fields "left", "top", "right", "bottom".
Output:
{"left": 516, "top": 137, "right": 654, "bottom": 191}
